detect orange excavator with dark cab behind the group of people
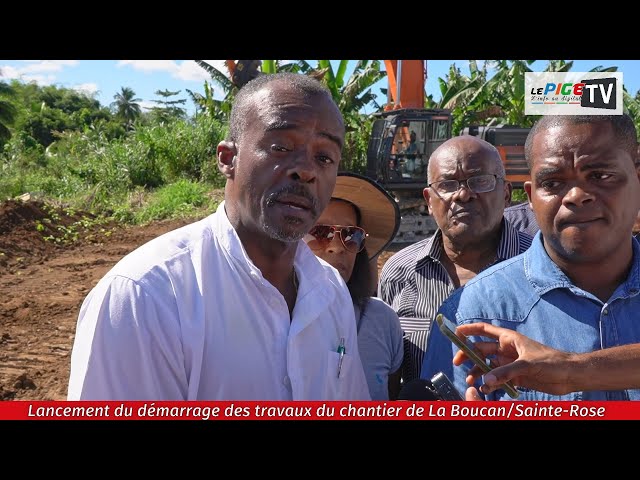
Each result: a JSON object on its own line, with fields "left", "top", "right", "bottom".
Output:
{"left": 367, "top": 60, "right": 529, "bottom": 243}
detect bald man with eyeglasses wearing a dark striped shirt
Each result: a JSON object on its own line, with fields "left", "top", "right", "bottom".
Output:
{"left": 378, "top": 135, "right": 531, "bottom": 382}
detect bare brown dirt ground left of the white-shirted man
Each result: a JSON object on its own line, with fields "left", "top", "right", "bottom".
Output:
{"left": 0, "top": 201, "right": 392, "bottom": 400}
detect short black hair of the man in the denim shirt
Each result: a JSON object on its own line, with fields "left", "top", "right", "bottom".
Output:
{"left": 524, "top": 113, "right": 638, "bottom": 169}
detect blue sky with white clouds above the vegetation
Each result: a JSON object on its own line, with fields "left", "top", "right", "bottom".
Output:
{"left": 0, "top": 60, "right": 640, "bottom": 113}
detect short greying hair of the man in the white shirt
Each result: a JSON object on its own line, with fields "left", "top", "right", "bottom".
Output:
{"left": 226, "top": 72, "right": 337, "bottom": 142}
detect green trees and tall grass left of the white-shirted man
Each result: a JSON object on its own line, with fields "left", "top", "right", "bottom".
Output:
{"left": 0, "top": 77, "right": 226, "bottom": 225}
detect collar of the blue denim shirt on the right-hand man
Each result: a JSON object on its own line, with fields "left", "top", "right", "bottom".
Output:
{"left": 524, "top": 231, "right": 640, "bottom": 299}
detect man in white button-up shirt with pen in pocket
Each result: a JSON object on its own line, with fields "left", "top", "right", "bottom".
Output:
{"left": 68, "top": 74, "right": 370, "bottom": 400}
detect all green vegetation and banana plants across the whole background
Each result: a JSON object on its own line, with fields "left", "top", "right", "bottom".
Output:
{"left": 0, "top": 60, "right": 640, "bottom": 231}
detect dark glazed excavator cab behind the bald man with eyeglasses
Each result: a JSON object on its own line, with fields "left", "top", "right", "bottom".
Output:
{"left": 367, "top": 109, "right": 451, "bottom": 190}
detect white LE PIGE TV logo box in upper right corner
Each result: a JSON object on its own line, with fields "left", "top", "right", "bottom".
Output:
{"left": 525, "top": 72, "right": 623, "bottom": 115}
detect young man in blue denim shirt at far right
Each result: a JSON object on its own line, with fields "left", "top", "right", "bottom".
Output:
{"left": 421, "top": 115, "right": 640, "bottom": 400}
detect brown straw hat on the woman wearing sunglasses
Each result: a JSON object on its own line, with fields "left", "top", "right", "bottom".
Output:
{"left": 331, "top": 172, "right": 400, "bottom": 259}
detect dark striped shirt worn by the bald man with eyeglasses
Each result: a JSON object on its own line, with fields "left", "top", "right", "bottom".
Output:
{"left": 378, "top": 220, "right": 531, "bottom": 382}
